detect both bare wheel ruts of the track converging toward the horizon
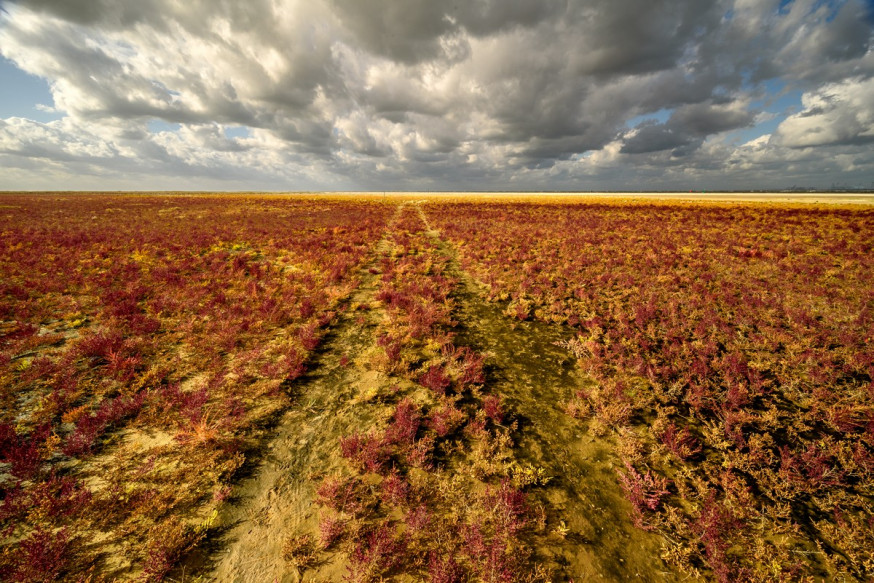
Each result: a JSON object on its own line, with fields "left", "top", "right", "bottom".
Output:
{"left": 186, "top": 203, "right": 677, "bottom": 583}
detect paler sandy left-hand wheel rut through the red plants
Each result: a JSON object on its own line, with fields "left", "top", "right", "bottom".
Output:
{"left": 177, "top": 208, "right": 406, "bottom": 583}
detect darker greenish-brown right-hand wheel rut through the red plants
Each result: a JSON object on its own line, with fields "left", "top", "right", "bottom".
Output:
{"left": 420, "top": 207, "right": 678, "bottom": 581}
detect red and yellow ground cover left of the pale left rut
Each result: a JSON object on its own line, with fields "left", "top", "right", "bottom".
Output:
{"left": 0, "top": 195, "right": 394, "bottom": 581}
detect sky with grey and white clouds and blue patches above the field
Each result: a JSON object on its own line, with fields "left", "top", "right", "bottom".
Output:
{"left": 0, "top": 0, "right": 874, "bottom": 191}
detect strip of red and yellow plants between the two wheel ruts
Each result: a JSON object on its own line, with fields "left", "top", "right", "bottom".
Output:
{"left": 310, "top": 207, "right": 544, "bottom": 583}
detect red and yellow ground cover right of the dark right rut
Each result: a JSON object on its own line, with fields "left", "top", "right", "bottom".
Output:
{"left": 426, "top": 202, "right": 874, "bottom": 581}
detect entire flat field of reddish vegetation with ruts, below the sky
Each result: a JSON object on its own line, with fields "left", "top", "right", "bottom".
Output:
{"left": 0, "top": 193, "right": 874, "bottom": 583}
